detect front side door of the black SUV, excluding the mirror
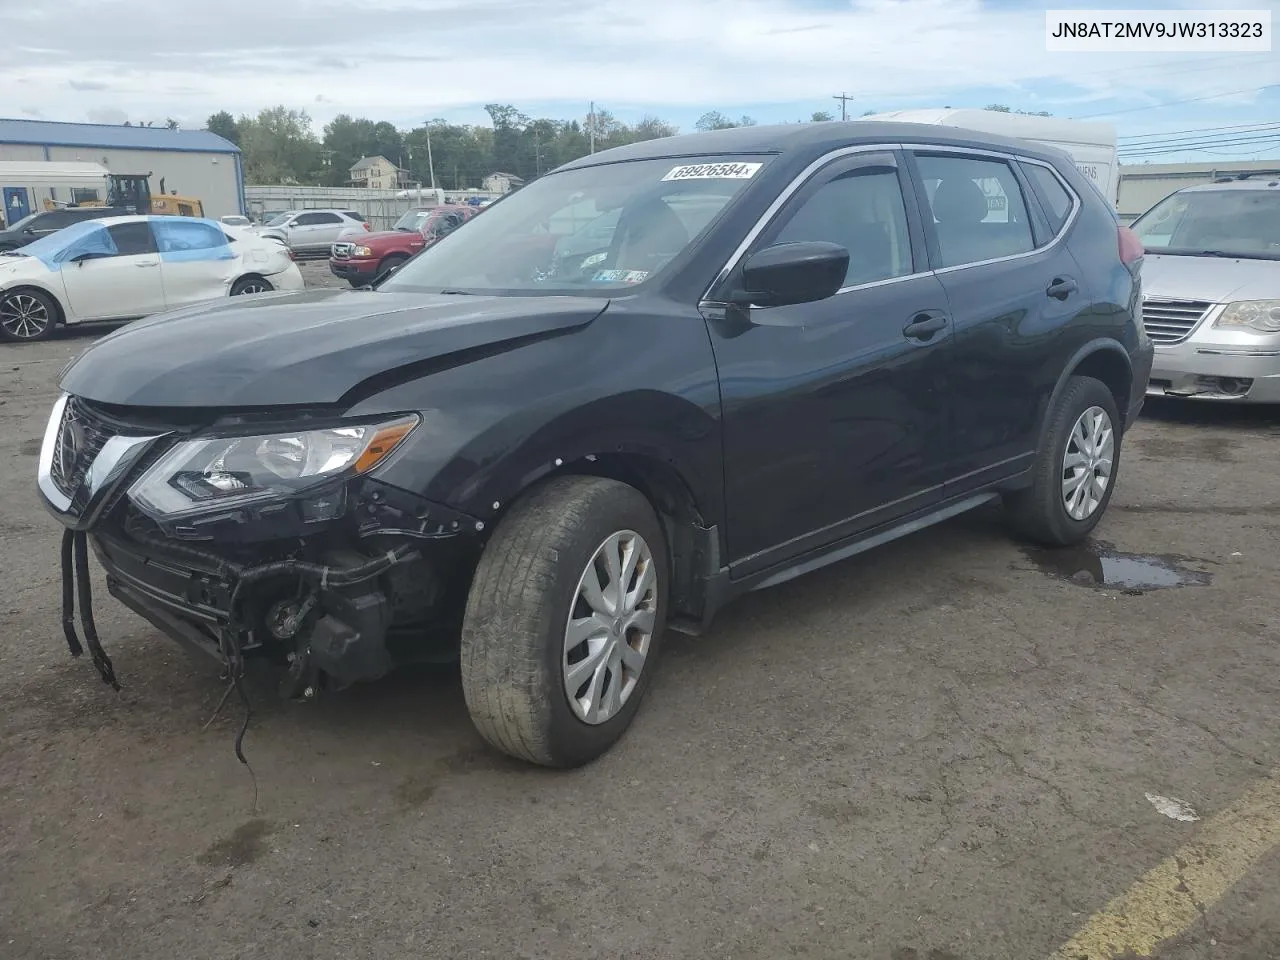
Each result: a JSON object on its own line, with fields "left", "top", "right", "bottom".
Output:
{"left": 709, "top": 151, "right": 951, "bottom": 576}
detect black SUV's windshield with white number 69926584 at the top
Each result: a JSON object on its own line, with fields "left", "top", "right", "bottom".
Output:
{"left": 380, "top": 157, "right": 767, "bottom": 296}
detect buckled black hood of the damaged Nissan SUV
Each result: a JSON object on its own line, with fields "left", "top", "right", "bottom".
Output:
{"left": 61, "top": 289, "right": 608, "bottom": 407}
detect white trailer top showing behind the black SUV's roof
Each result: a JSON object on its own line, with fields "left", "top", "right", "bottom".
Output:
{"left": 859, "top": 106, "right": 1120, "bottom": 206}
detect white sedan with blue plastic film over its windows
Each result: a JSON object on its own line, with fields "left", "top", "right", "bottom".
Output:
{"left": 0, "top": 216, "right": 303, "bottom": 340}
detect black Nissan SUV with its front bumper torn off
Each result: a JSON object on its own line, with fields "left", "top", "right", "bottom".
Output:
{"left": 38, "top": 122, "right": 1152, "bottom": 765}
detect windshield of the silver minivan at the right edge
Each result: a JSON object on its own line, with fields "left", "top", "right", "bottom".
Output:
{"left": 1132, "top": 189, "right": 1280, "bottom": 260}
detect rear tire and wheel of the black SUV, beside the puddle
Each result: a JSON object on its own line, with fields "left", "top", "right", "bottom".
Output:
{"left": 1005, "top": 376, "right": 1123, "bottom": 547}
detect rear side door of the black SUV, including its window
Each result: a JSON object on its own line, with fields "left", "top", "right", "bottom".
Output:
{"left": 911, "top": 147, "right": 1089, "bottom": 497}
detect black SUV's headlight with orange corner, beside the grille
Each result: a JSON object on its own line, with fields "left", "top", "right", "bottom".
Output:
{"left": 129, "top": 416, "right": 419, "bottom": 520}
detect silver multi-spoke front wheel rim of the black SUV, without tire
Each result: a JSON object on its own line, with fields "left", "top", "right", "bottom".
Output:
{"left": 561, "top": 530, "right": 658, "bottom": 724}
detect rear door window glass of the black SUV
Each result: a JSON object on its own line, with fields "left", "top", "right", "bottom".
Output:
{"left": 919, "top": 156, "right": 1036, "bottom": 266}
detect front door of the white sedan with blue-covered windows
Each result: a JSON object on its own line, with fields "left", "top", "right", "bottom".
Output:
{"left": 60, "top": 220, "right": 164, "bottom": 320}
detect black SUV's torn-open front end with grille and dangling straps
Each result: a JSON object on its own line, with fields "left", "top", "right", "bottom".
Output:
{"left": 38, "top": 397, "right": 483, "bottom": 696}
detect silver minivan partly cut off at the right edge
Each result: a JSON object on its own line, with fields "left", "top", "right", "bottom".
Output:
{"left": 1132, "top": 177, "right": 1280, "bottom": 403}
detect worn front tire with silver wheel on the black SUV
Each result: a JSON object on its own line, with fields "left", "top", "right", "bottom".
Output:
{"left": 461, "top": 476, "right": 669, "bottom": 767}
